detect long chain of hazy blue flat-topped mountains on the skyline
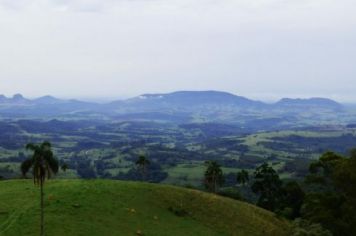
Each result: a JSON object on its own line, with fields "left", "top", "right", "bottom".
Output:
{"left": 0, "top": 91, "right": 343, "bottom": 122}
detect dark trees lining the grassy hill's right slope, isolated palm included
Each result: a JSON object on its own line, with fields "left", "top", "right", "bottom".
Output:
{"left": 204, "top": 149, "right": 356, "bottom": 236}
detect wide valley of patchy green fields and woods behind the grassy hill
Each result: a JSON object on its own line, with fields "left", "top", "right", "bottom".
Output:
{"left": 0, "top": 120, "right": 356, "bottom": 187}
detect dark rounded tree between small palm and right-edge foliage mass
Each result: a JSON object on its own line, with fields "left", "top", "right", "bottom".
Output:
{"left": 251, "top": 163, "right": 282, "bottom": 211}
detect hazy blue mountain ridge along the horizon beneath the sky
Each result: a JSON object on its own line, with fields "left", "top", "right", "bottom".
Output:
{"left": 0, "top": 91, "right": 343, "bottom": 120}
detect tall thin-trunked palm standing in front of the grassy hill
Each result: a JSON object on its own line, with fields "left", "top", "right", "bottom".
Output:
{"left": 21, "top": 142, "right": 58, "bottom": 236}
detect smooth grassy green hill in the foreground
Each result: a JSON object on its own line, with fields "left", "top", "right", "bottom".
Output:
{"left": 0, "top": 180, "right": 289, "bottom": 236}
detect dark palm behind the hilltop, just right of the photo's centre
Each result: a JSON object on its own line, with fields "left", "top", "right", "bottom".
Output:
{"left": 204, "top": 161, "right": 224, "bottom": 193}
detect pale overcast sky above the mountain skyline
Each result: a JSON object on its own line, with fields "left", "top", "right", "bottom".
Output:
{"left": 0, "top": 0, "right": 356, "bottom": 102}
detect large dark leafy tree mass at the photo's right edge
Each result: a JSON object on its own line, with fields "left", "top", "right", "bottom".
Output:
{"left": 302, "top": 150, "right": 356, "bottom": 236}
